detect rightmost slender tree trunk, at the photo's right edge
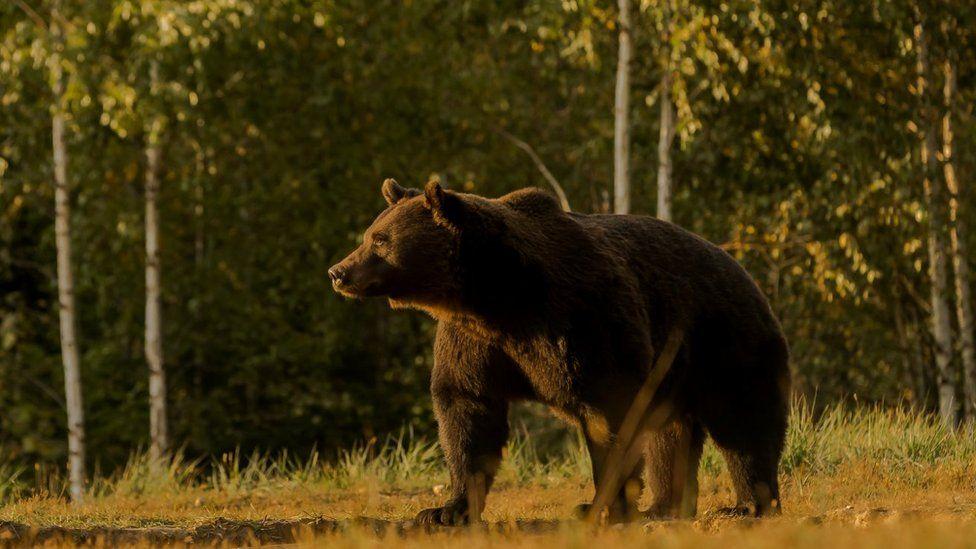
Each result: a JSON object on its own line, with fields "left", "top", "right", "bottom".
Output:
{"left": 942, "top": 60, "right": 976, "bottom": 419}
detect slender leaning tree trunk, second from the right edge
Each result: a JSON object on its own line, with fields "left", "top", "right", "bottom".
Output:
{"left": 915, "top": 17, "right": 956, "bottom": 426}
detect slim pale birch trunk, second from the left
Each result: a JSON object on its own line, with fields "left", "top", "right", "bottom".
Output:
{"left": 146, "top": 60, "right": 169, "bottom": 463}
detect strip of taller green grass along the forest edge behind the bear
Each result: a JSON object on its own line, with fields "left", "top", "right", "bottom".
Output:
{"left": 0, "top": 402, "right": 976, "bottom": 504}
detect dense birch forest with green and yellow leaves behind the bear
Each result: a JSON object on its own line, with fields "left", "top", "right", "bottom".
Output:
{"left": 0, "top": 0, "right": 976, "bottom": 510}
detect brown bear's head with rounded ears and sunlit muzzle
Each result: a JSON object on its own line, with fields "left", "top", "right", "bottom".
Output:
{"left": 329, "top": 179, "right": 463, "bottom": 306}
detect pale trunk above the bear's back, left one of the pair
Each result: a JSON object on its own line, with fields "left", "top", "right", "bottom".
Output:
{"left": 613, "top": 0, "right": 632, "bottom": 214}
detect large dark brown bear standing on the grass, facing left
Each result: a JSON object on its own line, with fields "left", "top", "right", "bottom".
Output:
{"left": 329, "top": 180, "right": 790, "bottom": 525}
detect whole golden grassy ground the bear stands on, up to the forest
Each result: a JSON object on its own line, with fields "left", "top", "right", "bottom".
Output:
{"left": 0, "top": 406, "right": 976, "bottom": 547}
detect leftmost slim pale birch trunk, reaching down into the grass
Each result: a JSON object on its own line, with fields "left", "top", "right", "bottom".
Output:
{"left": 51, "top": 2, "right": 85, "bottom": 503}
